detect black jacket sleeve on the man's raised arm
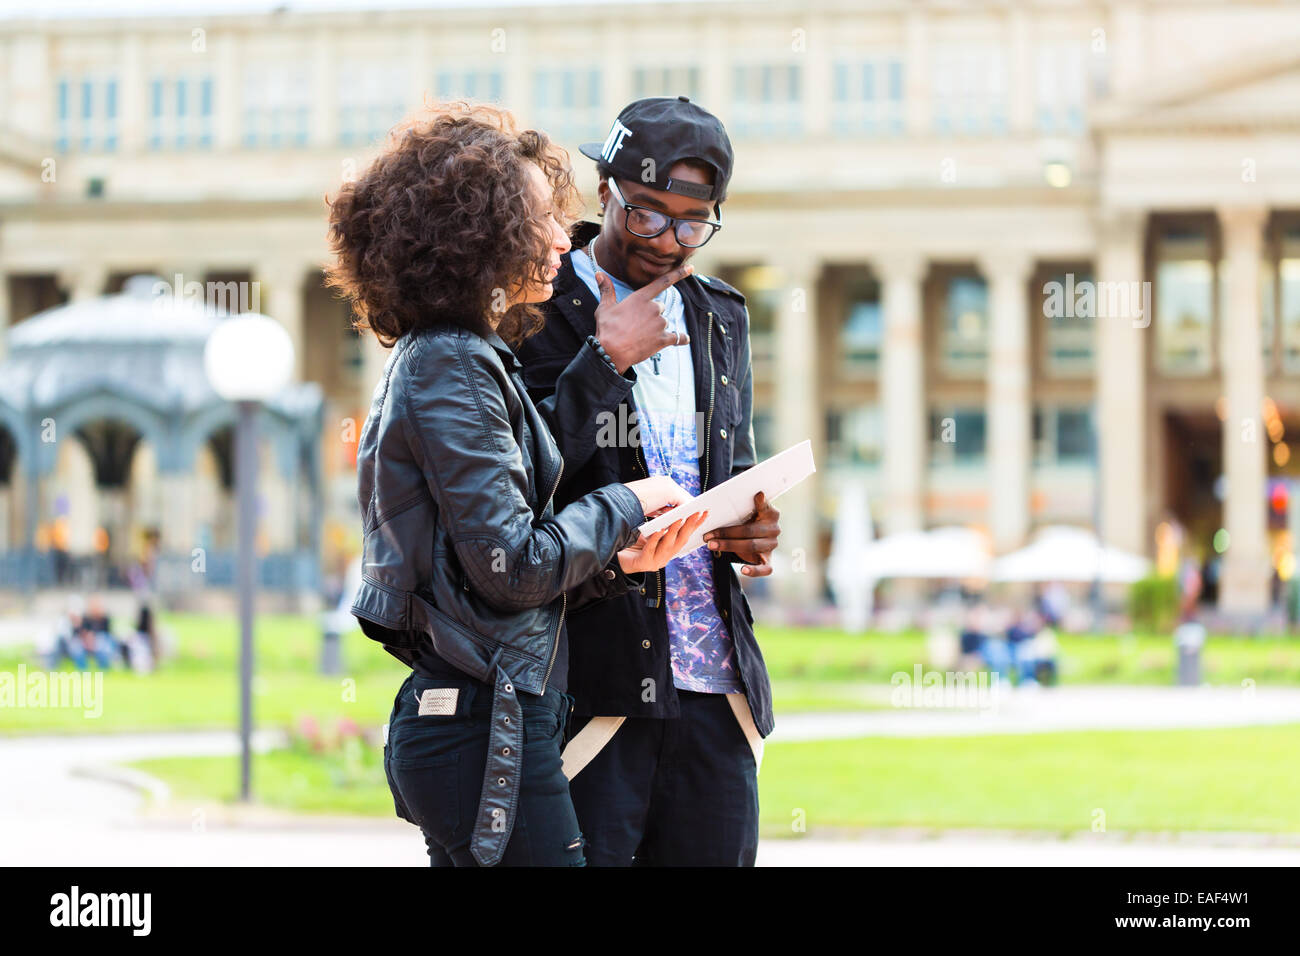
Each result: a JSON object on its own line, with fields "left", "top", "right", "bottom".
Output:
{"left": 533, "top": 342, "right": 637, "bottom": 475}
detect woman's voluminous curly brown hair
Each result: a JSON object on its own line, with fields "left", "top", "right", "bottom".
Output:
{"left": 325, "top": 100, "right": 580, "bottom": 347}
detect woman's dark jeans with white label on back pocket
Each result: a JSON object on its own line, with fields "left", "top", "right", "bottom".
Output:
{"left": 384, "top": 672, "right": 586, "bottom": 866}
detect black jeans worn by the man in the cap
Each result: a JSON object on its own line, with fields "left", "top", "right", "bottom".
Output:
{"left": 569, "top": 691, "right": 758, "bottom": 866}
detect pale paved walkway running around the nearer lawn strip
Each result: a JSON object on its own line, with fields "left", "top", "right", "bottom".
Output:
{"left": 0, "top": 688, "right": 1300, "bottom": 866}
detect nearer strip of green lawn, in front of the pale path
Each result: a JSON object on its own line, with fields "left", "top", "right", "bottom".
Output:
{"left": 135, "top": 726, "right": 1300, "bottom": 836}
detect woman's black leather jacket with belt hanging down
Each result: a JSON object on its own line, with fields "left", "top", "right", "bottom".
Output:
{"left": 352, "top": 325, "right": 645, "bottom": 865}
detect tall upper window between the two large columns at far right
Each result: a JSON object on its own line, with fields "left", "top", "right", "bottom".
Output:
{"left": 1156, "top": 226, "right": 1214, "bottom": 375}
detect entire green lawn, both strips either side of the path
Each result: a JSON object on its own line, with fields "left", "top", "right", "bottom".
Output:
{"left": 12, "top": 614, "right": 1300, "bottom": 835}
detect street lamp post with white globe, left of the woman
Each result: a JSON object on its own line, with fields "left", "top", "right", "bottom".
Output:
{"left": 203, "top": 312, "right": 294, "bottom": 801}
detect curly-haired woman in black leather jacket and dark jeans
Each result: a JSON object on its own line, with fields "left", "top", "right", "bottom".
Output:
{"left": 330, "top": 104, "right": 705, "bottom": 865}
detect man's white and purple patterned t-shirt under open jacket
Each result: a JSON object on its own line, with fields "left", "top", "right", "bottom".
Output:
{"left": 572, "top": 248, "right": 744, "bottom": 693}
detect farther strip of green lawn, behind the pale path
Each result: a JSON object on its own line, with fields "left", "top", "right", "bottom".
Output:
{"left": 0, "top": 614, "right": 1300, "bottom": 734}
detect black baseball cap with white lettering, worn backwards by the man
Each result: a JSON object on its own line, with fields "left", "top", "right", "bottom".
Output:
{"left": 579, "top": 96, "right": 735, "bottom": 203}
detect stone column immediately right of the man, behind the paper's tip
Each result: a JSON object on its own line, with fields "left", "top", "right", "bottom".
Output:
{"left": 774, "top": 256, "right": 824, "bottom": 607}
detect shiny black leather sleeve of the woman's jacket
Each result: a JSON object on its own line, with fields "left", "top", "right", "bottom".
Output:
{"left": 406, "top": 336, "right": 645, "bottom": 613}
